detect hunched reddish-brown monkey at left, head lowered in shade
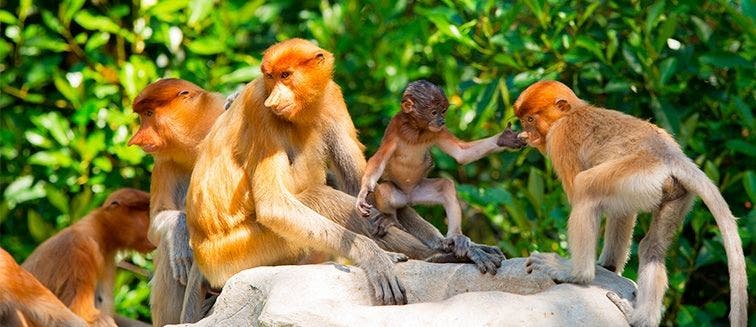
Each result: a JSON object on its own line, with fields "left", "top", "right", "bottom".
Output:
{"left": 22, "top": 188, "right": 155, "bottom": 326}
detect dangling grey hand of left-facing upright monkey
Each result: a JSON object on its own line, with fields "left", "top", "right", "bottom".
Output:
{"left": 166, "top": 212, "right": 192, "bottom": 285}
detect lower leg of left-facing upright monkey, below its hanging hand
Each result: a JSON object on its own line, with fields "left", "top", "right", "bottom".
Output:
{"left": 150, "top": 240, "right": 185, "bottom": 326}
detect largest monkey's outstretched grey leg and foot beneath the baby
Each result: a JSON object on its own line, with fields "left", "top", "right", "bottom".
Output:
{"left": 296, "top": 185, "right": 437, "bottom": 259}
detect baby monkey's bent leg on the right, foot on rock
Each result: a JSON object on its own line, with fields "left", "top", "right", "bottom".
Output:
{"left": 409, "top": 178, "right": 470, "bottom": 257}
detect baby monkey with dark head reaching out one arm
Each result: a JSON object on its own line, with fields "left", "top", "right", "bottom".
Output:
{"left": 357, "top": 80, "right": 526, "bottom": 257}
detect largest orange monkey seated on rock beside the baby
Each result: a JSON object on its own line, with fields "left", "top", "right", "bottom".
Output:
{"left": 186, "top": 39, "right": 414, "bottom": 304}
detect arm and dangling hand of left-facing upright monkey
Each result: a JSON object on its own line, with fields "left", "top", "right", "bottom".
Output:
{"left": 147, "top": 161, "right": 193, "bottom": 285}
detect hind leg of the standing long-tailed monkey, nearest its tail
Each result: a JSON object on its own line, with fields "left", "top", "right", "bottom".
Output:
{"left": 630, "top": 194, "right": 694, "bottom": 326}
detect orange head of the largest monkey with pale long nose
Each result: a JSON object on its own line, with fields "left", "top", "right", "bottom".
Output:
{"left": 260, "top": 39, "right": 333, "bottom": 121}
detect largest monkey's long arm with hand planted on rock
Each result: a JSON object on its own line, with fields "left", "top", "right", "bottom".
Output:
{"left": 251, "top": 151, "right": 406, "bottom": 304}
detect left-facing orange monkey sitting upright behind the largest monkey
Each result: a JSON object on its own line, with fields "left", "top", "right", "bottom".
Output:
{"left": 129, "top": 78, "right": 224, "bottom": 326}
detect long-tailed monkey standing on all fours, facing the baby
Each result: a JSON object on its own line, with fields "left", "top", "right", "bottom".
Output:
{"left": 514, "top": 81, "right": 748, "bottom": 326}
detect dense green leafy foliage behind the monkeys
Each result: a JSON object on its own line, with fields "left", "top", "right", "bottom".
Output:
{"left": 0, "top": 0, "right": 756, "bottom": 325}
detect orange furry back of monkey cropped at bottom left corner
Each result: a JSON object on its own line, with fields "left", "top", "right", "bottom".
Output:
{"left": 0, "top": 248, "right": 87, "bottom": 327}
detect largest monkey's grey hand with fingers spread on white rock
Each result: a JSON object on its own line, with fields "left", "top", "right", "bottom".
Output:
{"left": 359, "top": 246, "right": 407, "bottom": 305}
